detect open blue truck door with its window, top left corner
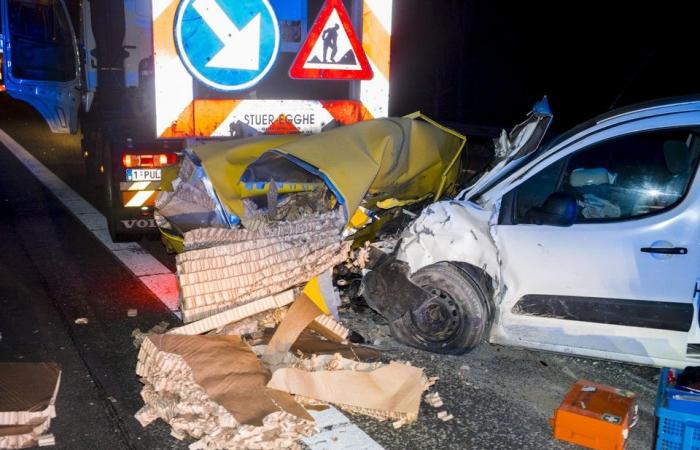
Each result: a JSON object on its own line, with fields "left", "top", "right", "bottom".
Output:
{"left": 0, "top": 0, "right": 80, "bottom": 133}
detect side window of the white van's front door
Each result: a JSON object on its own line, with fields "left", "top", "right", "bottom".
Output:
{"left": 515, "top": 130, "right": 700, "bottom": 223}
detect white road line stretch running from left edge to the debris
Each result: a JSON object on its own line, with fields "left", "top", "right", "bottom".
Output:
{"left": 0, "top": 129, "right": 179, "bottom": 311}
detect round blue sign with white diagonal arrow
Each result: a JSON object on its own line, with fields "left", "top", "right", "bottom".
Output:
{"left": 175, "top": 0, "right": 280, "bottom": 91}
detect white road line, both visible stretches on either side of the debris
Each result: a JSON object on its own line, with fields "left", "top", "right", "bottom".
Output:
{"left": 0, "top": 128, "right": 383, "bottom": 450}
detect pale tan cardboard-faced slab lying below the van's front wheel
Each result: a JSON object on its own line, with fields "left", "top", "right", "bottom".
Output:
{"left": 267, "top": 362, "right": 425, "bottom": 421}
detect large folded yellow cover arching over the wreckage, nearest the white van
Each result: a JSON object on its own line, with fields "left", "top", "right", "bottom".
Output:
{"left": 243, "top": 113, "right": 466, "bottom": 220}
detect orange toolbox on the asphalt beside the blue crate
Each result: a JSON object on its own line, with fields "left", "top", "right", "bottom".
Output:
{"left": 550, "top": 380, "right": 638, "bottom": 450}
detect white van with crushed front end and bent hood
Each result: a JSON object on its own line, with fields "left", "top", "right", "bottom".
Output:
{"left": 363, "top": 98, "right": 700, "bottom": 367}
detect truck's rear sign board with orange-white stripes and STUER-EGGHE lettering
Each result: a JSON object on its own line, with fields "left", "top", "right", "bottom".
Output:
{"left": 151, "top": 0, "right": 393, "bottom": 138}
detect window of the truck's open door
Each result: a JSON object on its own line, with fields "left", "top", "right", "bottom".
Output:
{"left": 5, "top": 0, "right": 76, "bottom": 81}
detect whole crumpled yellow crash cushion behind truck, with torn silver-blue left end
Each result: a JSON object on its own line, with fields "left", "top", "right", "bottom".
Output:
{"left": 156, "top": 113, "right": 466, "bottom": 252}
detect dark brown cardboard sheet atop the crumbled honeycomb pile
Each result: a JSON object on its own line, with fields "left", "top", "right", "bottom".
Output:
{"left": 148, "top": 335, "right": 313, "bottom": 426}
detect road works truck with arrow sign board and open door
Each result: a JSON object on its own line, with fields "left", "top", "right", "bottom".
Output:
{"left": 0, "top": 0, "right": 393, "bottom": 241}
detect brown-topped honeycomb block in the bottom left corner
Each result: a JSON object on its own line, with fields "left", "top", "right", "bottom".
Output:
{"left": 0, "top": 363, "right": 61, "bottom": 449}
